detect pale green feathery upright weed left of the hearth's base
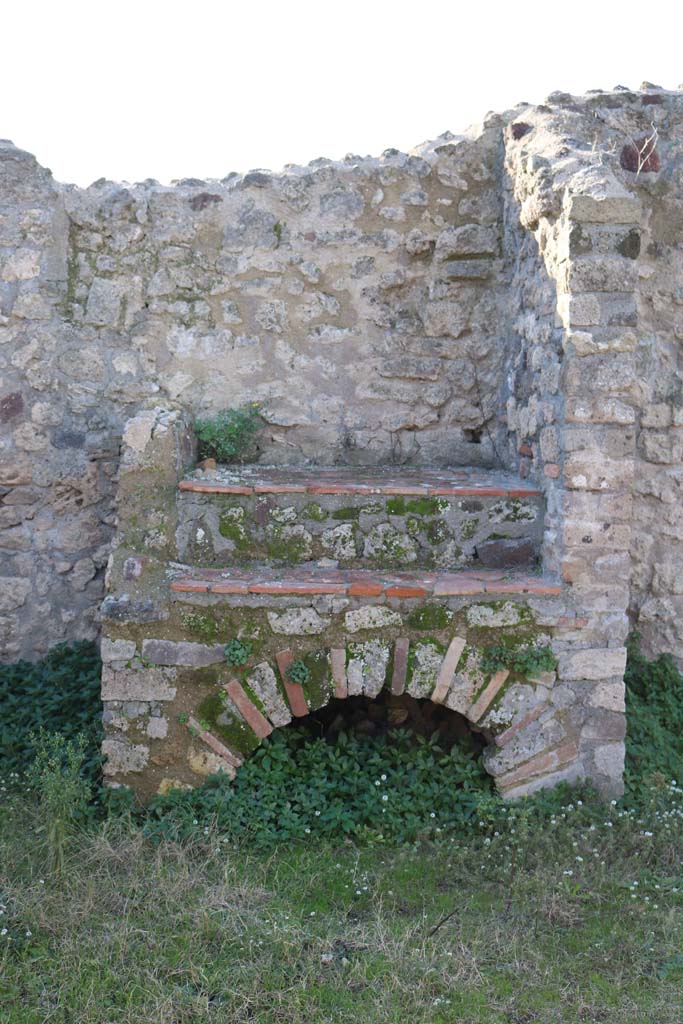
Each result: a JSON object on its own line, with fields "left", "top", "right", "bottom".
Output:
{"left": 29, "top": 729, "right": 92, "bottom": 874}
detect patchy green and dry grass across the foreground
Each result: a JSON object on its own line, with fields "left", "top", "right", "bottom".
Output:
{"left": 0, "top": 784, "right": 683, "bottom": 1024}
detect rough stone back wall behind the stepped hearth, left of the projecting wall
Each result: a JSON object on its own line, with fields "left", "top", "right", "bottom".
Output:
{"left": 0, "top": 119, "right": 507, "bottom": 658}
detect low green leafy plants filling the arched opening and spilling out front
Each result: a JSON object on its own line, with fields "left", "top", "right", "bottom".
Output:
{"left": 143, "top": 729, "right": 493, "bottom": 848}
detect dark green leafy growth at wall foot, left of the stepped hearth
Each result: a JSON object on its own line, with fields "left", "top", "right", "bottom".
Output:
{"left": 0, "top": 641, "right": 102, "bottom": 784}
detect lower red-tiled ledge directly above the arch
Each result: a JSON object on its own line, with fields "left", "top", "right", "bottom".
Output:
{"left": 171, "top": 568, "right": 562, "bottom": 598}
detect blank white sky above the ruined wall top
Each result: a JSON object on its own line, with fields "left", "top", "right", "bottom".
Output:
{"left": 5, "top": 0, "right": 683, "bottom": 185}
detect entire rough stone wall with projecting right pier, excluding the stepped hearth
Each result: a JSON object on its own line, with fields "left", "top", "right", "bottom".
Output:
{"left": 0, "top": 87, "right": 683, "bottom": 678}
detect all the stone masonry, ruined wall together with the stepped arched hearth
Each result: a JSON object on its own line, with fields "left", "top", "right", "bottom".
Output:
{"left": 5, "top": 86, "right": 683, "bottom": 795}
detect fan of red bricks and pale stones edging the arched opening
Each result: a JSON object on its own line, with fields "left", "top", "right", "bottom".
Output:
{"left": 187, "top": 636, "right": 551, "bottom": 777}
